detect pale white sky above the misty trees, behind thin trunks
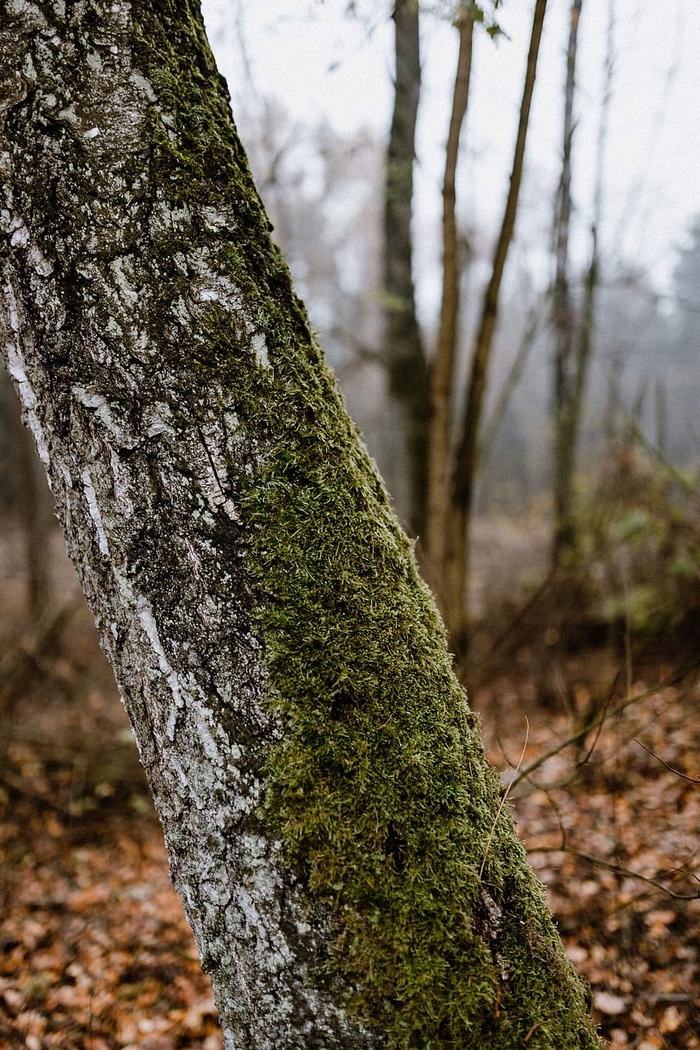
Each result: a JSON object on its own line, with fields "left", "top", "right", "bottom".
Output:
{"left": 203, "top": 0, "right": 700, "bottom": 304}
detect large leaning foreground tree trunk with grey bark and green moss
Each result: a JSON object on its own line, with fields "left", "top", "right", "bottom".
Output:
{"left": 0, "top": 0, "right": 597, "bottom": 1050}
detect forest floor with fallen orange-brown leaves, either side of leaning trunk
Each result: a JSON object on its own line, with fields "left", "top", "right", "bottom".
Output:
{"left": 0, "top": 520, "right": 700, "bottom": 1050}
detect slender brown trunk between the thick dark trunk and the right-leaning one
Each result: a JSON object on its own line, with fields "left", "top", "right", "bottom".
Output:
{"left": 426, "top": 12, "right": 474, "bottom": 601}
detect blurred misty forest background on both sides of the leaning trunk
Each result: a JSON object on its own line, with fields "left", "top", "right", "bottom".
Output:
{"left": 0, "top": 0, "right": 700, "bottom": 1050}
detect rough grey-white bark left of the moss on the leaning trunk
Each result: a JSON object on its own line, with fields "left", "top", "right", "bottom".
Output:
{"left": 2, "top": 2, "right": 358, "bottom": 1050}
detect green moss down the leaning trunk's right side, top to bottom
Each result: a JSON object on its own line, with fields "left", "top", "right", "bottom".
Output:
{"left": 134, "top": 2, "right": 598, "bottom": 1050}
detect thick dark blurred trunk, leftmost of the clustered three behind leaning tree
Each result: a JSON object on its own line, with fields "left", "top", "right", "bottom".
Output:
{"left": 383, "top": 0, "right": 429, "bottom": 536}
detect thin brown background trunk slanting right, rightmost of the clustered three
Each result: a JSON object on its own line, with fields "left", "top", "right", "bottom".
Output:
{"left": 445, "top": 0, "right": 547, "bottom": 658}
